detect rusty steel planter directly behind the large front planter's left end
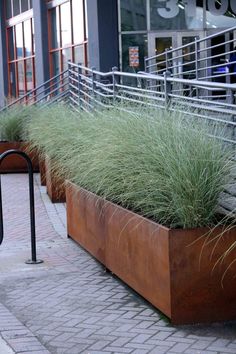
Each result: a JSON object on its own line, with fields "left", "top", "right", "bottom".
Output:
{"left": 45, "top": 157, "right": 66, "bottom": 203}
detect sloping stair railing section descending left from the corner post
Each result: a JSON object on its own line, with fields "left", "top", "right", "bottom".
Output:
{"left": 0, "top": 69, "right": 68, "bottom": 112}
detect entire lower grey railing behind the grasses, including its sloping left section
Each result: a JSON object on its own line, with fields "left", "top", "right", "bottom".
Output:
{"left": 0, "top": 62, "right": 236, "bottom": 214}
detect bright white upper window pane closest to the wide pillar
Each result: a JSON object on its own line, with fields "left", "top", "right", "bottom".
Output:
{"left": 72, "top": 0, "right": 85, "bottom": 44}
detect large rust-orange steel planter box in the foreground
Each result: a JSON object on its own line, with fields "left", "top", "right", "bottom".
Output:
{"left": 66, "top": 182, "right": 236, "bottom": 324}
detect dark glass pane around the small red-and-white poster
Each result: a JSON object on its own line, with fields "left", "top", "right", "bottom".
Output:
{"left": 122, "top": 34, "right": 147, "bottom": 72}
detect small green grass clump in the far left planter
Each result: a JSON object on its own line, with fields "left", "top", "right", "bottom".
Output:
{"left": 0, "top": 105, "right": 37, "bottom": 141}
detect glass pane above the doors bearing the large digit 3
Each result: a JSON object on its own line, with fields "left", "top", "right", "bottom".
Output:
{"left": 150, "top": 0, "right": 204, "bottom": 30}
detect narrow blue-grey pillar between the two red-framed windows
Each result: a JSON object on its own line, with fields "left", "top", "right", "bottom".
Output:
{"left": 33, "top": 0, "right": 50, "bottom": 86}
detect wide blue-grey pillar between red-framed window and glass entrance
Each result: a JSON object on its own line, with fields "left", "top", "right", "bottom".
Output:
{"left": 87, "top": 0, "right": 119, "bottom": 71}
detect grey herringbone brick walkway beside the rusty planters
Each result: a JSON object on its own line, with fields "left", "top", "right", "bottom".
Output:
{"left": 0, "top": 174, "right": 236, "bottom": 354}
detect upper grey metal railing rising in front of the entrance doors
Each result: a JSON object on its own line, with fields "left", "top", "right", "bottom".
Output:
{"left": 145, "top": 27, "right": 236, "bottom": 83}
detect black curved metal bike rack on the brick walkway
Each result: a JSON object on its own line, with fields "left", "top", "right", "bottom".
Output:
{"left": 0, "top": 150, "right": 43, "bottom": 264}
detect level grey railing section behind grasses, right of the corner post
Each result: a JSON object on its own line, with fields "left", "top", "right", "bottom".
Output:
{"left": 68, "top": 63, "right": 236, "bottom": 145}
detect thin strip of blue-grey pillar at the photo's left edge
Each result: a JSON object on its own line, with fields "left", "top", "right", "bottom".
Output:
{"left": 0, "top": 1, "right": 8, "bottom": 107}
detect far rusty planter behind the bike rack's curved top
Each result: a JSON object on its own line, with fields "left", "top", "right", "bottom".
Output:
{"left": 0, "top": 141, "right": 39, "bottom": 173}
